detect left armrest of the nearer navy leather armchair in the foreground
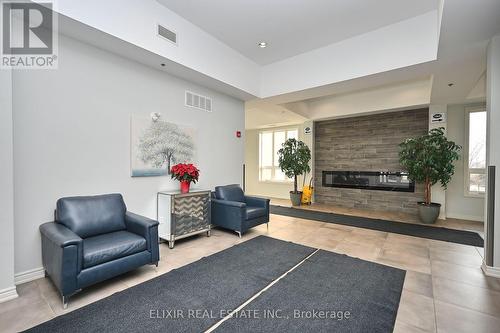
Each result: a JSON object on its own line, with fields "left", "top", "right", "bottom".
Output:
{"left": 40, "top": 222, "right": 83, "bottom": 296}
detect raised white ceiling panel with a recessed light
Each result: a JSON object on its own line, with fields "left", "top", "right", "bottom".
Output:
{"left": 157, "top": 0, "right": 438, "bottom": 65}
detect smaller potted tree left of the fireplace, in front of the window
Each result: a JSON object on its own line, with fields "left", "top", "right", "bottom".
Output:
{"left": 278, "top": 138, "right": 311, "bottom": 206}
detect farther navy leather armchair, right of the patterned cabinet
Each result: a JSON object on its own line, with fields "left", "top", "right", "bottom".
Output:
{"left": 212, "top": 185, "right": 269, "bottom": 238}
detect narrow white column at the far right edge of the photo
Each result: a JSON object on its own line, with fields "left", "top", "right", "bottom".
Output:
{"left": 483, "top": 35, "right": 500, "bottom": 277}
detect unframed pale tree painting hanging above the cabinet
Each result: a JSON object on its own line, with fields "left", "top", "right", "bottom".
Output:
{"left": 131, "top": 117, "right": 195, "bottom": 177}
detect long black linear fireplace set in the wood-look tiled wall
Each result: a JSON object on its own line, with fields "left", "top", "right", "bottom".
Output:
{"left": 322, "top": 171, "right": 415, "bottom": 192}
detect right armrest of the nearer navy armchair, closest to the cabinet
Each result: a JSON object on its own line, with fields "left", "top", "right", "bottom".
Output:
{"left": 125, "top": 212, "right": 160, "bottom": 262}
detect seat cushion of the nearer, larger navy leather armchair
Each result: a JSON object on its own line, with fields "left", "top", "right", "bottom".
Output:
{"left": 83, "top": 230, "right": 147, "bottom": 268}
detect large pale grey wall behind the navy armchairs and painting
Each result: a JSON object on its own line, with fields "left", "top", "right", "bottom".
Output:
{"left": 13, "top": 37, "right": 244, "bottom": 273}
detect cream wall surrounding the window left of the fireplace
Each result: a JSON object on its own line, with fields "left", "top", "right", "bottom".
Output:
{"left": 245, "top": 121, "right": 314, "bottom": 199}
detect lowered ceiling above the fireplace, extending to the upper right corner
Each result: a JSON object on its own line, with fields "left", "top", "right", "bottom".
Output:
{"left": 246, "top": 0, "right": 500, "bottom": 127}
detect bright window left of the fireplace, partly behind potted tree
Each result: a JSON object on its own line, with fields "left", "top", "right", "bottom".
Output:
{"left": 259, "top": 128, "right": 299, "bottom": 182}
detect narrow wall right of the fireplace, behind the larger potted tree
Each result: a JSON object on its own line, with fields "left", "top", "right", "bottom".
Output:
{"left": 446, "top": 104, "right": 484, "bottom": 221}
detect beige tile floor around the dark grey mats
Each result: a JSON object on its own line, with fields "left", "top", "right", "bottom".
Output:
{"left": 0, "top": 215, "right": 494, "bottom": 333}
